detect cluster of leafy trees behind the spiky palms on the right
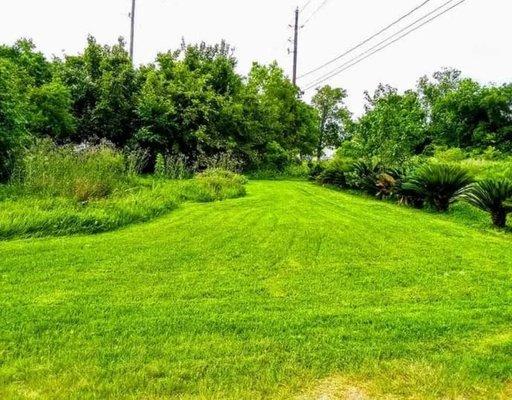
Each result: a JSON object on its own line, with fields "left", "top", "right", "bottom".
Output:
{"left": 340, "top": 69, "right": 512, "bottom": 165}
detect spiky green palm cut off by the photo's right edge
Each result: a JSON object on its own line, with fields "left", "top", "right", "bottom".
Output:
{"left": 458, "top": 179, "right": 512, "bottom": 228}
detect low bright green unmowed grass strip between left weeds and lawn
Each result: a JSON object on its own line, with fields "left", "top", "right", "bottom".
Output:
{"left": 0, "top": 172, "right": 245, "bottom": 239}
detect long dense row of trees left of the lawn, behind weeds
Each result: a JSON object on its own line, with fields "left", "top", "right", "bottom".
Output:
{"left": 0, "top": 37, "right": 323, "bottom": 180}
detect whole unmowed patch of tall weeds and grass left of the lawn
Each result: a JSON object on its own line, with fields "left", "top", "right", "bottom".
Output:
{"left": 0, "top": 141, "right": 246, "bottom": 239}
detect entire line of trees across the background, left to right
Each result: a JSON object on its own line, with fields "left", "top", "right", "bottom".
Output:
{"left": 0, "top": 37, "right": 512, "bottom": 180}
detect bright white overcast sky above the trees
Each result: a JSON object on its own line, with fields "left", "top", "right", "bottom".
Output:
{"left": 0, "top": 0, "right": 512, "bottom": 113}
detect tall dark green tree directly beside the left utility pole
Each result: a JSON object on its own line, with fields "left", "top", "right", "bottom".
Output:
{"left": 54, "top": 36, "right": 139, "bottom": 146}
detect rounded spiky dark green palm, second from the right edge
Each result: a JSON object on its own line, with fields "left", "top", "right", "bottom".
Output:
{"left": 403, "top": 164, "right": 473, "bottom": 212}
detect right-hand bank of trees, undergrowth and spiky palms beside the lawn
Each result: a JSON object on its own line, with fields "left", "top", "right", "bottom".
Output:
{"left": 311, "top": 70, "right": 512, "bottom": 228}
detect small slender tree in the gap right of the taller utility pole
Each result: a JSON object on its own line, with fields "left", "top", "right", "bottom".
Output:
{"left": 312, "top": 85, "right": 350, "bottom": 160}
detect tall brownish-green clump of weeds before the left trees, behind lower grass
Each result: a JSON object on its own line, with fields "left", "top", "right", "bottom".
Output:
{"left": 15, "top": 140, "right": 127, "bottom": 201}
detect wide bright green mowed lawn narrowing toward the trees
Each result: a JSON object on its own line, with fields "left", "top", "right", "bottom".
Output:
{"left": 0, "top": 182, "right": 512, "bottom": 399}
